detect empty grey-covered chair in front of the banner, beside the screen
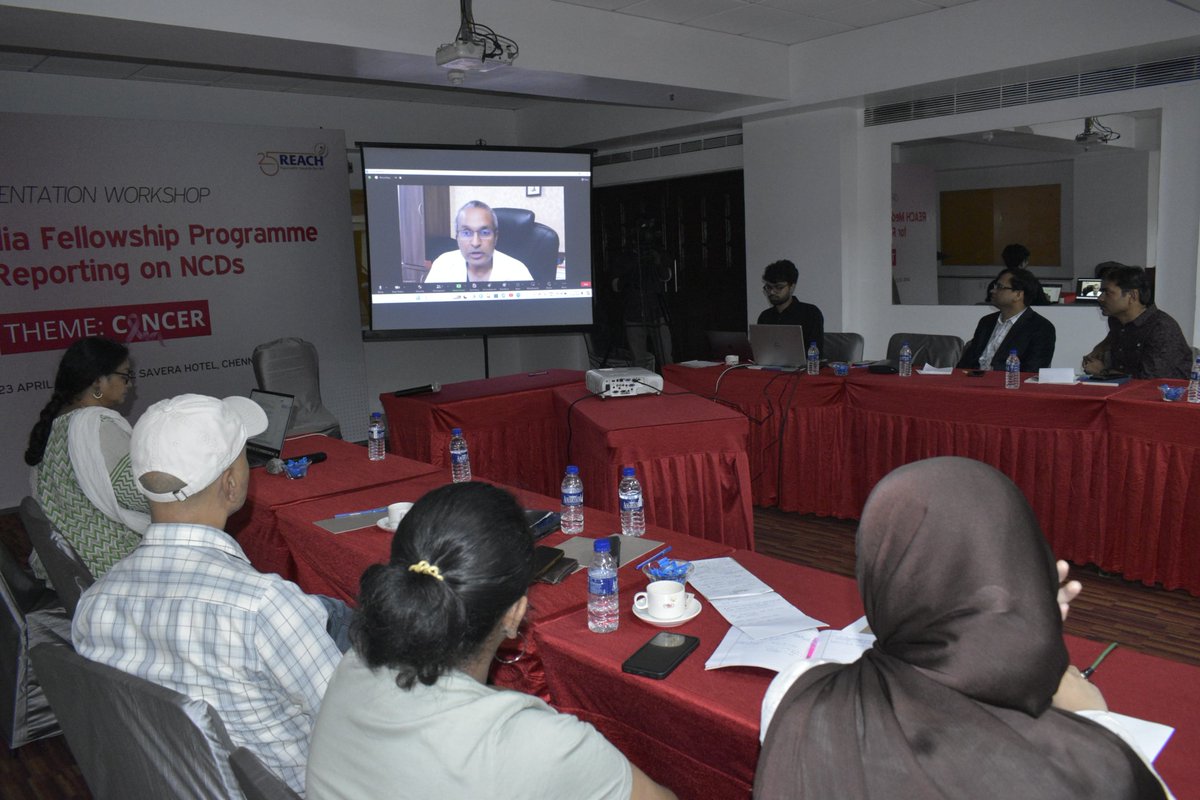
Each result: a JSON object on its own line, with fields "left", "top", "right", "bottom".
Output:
{"left": 251, "top": 337, "right": 342, "bottom": 439}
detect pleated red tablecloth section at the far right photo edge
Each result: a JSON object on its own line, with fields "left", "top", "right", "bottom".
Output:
{"left": 1094, "top": 380, "right": 1200, "bottom": 594}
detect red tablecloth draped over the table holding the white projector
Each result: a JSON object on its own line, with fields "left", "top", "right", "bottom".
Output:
{"left": 553, "top": 384, "right": 754, "bottom": 549}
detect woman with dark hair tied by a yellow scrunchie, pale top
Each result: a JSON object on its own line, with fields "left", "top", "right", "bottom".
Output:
{"left": 307, "top": 483, "right": 674, "bottom": 800}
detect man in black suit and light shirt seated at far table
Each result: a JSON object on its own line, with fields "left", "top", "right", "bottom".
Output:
{"left": 959, "top": 267, "right": 1055, "bottom": 372}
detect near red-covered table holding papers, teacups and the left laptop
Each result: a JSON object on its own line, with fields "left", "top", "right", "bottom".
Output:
{"left": 230, "top": 440, "right": 1200, "bottom": 800}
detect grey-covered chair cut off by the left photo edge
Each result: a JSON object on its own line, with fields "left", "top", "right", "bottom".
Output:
{"left": 0, "top": 545, "right": 71, "bottom": 750}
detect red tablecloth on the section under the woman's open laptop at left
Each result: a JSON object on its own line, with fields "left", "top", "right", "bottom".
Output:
{"left": 226, "top": 435, "right": 443, "bottom": 577}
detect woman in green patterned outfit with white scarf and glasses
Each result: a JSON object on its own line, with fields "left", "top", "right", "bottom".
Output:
{"left": 25, "top": 336, "right": 150, "bottom": 578}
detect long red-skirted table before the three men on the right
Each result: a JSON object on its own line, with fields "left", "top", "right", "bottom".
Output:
{"left": 664, "top": 365, "right": 1200, "bottom": 595}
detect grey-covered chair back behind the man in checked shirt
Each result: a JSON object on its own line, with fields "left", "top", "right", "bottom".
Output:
{"left": 30, "top": 644, "right": 242, "bottom": 800}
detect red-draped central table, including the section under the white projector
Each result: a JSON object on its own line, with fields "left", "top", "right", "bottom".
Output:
{"left": 379, "top": 369, "right": 754, "bottom": 549}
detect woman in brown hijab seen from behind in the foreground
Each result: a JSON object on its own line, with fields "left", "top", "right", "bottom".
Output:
{"left": 755, "top": 458, "right": 1166, "bottom": 800}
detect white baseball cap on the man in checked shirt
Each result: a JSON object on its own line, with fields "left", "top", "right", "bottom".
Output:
{"left": 130, "top": 395, "right": 266, "bottom": 503}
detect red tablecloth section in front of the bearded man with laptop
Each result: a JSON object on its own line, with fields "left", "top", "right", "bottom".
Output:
{"left": 662, "top": 365, "right": 846, "bottom": 517}
